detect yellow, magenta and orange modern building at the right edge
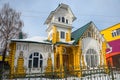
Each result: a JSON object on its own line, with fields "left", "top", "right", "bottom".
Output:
{"left": 101, "top": 23, "right": 120, "bottom": 67}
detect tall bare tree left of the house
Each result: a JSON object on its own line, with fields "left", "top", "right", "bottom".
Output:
{"left": 0, "top": 4, "right": 23, "bottom": 79}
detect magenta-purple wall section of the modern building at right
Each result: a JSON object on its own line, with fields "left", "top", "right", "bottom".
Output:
{"left": 108, "top": 39, "right": 120, "bottom": 53}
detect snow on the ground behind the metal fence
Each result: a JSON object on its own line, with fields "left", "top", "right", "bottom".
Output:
{"left": 4, "top": 74, "right": 120, "bottom": 80}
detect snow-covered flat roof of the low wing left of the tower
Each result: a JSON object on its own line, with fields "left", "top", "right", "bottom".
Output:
{"left": 11, "top": 36, "right": 51, "bottom": 44}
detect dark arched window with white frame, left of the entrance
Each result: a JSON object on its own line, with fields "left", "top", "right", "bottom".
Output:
{"left": 28, "top": 52, "right": 43, "bottom": 68}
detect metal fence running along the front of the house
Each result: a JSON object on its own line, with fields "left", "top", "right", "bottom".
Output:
{"left": 3, "top": 67, "right": 120, "bottom": 80}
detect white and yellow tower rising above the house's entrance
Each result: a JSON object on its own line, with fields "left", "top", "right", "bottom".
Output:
{"left": 45, "top": 3, "right": 76, "bottom": 43}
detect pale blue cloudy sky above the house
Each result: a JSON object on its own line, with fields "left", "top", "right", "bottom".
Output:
{"left": 0, "top": 0, "right": 120, "bottom": 37}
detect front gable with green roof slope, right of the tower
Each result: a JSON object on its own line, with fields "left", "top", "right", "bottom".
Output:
{"left": 71, "top": 21, "right": 104, "bottom": 44}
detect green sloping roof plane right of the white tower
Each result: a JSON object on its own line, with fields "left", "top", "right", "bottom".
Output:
{"left": 71, "top": 21, "right": 93, "bottom": 44}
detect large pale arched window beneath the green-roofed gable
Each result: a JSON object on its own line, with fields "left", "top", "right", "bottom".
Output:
{"left": 86, "top": 49, "right": 98, "bottom": 67}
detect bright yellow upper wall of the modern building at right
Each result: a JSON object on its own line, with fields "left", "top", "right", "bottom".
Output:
{"left": 101, "top": 23, "right": 120, "bottom": 42}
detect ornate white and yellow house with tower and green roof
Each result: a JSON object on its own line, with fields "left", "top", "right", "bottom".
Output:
{"left": 9, "top": 3, "right": 107, "bottom": 76}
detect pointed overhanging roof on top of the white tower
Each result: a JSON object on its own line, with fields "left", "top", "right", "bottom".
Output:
{"left": 44, "top": 3, "right": 76, "bottom": 24}
